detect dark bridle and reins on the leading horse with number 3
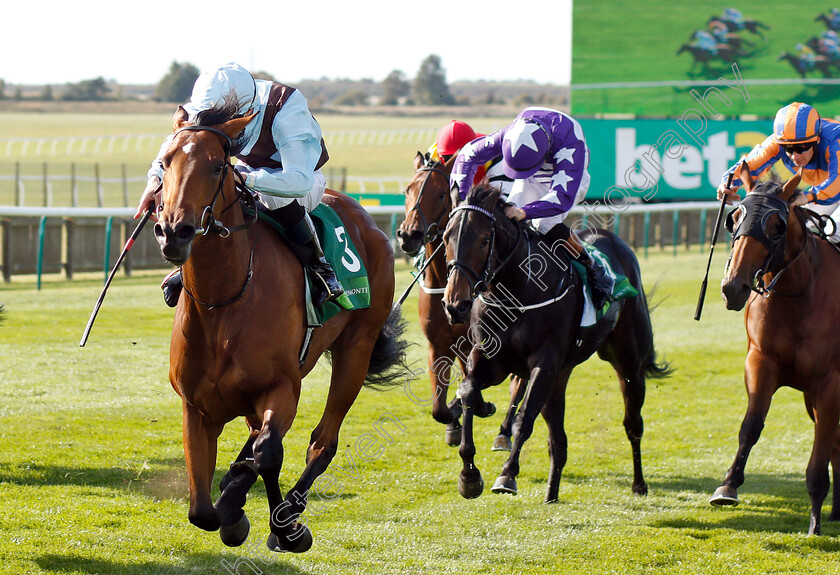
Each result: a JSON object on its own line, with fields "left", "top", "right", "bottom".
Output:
{"left": 174, "top": 125, "right": 259, "bottom": 310}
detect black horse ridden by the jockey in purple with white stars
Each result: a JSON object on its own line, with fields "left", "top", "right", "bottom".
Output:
{"left": 444, "top": 186, "right": 669, "bottom": 501}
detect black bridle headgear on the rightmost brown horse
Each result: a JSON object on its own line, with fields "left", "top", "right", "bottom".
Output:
{"left": 725, "top": 194, "right": 809, "bottom": 298}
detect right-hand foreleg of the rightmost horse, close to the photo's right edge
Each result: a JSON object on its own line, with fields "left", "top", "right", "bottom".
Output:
{"left": 805, "top": 385, "right": 840, "bottom": 535}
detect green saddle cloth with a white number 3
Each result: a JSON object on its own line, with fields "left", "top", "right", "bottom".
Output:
{"left": 258, "top": 204, "right": 370, "bottom": 326}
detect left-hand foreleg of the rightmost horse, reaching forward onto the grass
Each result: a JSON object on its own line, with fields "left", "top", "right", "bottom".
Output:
{"left": 709, "top": 352, "right": 778, "bottom": 507}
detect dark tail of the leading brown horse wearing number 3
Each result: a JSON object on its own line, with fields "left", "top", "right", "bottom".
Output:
{"left": 365, "top": 306, "right": 411, "bottom": 389}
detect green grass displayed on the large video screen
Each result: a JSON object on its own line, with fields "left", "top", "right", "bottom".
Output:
{"left": 572, "top": 0, "right": 840, "bottom": 117}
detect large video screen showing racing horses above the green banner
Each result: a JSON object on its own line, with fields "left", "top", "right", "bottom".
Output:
{"left": 571, "top": 0, "right": 840, "bottom": 118}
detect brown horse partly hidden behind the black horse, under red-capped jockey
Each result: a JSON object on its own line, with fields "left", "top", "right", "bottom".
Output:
{"left": 397, "top": 152, "right": 524, "bottom": 451}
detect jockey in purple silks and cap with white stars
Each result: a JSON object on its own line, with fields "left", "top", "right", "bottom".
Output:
{"left": 450, "top": 106, "right": 612, "bottom": 309}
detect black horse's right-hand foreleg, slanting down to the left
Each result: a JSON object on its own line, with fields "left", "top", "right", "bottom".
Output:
{"left": 491, "top": 364, "right": 571, "bottom": 493}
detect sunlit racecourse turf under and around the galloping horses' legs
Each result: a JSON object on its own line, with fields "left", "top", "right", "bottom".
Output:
{"left": 0, "top": 251, "right": 840, "bottom": 575}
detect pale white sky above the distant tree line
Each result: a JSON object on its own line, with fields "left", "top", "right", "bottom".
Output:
{"left": 6, "top": 0, "right": 572, "bottom": 85}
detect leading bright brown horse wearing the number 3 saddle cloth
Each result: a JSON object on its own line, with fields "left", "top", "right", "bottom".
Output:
{"left": 155, "top": 106, "right": 412, "bottom": 552}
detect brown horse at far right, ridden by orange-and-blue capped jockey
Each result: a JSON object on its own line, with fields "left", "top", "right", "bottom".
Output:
{"left": 710, "top": 165, "right": 840, "bottom": 535}
